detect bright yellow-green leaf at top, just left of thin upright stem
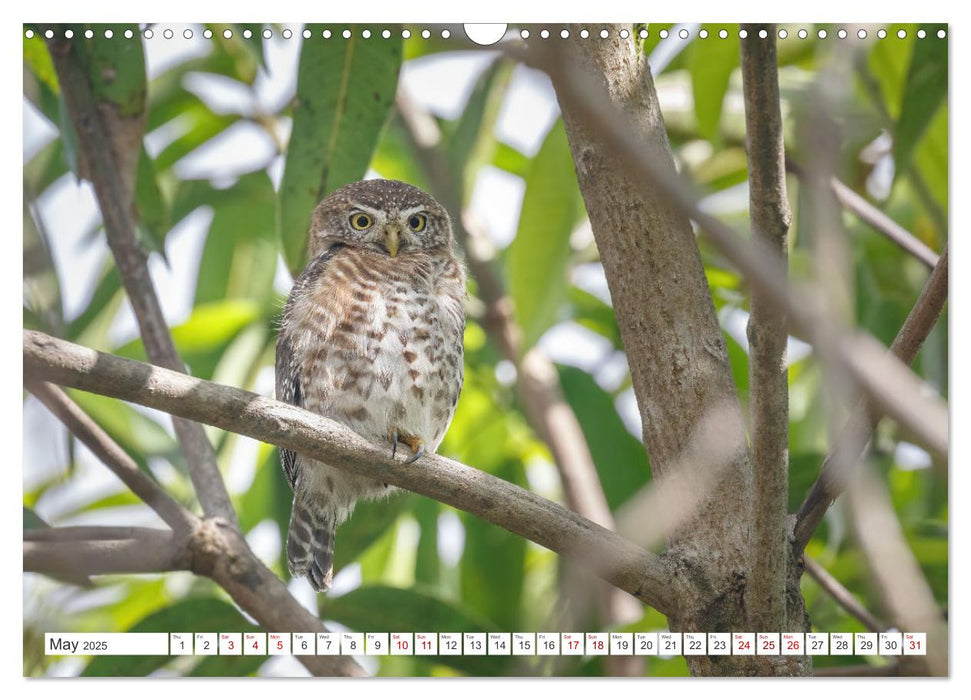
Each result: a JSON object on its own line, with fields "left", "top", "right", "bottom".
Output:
{"left": 687, "top": 24, "right": 740, "bottom": 143}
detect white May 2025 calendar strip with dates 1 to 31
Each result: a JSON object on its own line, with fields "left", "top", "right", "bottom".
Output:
{"left": 44, "top": 631, "right": 927, "bottom": 657}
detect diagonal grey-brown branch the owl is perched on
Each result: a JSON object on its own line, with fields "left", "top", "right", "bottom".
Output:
{"left": 24, "top": 331, "right": 687, "bottom": 613}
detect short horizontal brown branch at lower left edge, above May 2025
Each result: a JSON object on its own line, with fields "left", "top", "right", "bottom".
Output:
{"left": 24, "top": 528, "right": 190, "bottom": 578}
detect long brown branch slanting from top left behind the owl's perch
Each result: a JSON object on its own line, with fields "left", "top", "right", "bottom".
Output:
{"left": 48, "top": 32, "right": 236, "bottom": 523}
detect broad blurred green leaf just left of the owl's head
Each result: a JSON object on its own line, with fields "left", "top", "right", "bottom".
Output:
{"left": 195, "top": 170, "right": 277, "bottom": 305}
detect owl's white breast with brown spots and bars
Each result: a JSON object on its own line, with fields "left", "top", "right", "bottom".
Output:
{"left": 291, "top": 248, "right": 465, "bottom": 450}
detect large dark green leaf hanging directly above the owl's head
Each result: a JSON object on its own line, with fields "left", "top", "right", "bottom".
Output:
{"left": 278, "top": 25, "right": 402, "bottom": 276}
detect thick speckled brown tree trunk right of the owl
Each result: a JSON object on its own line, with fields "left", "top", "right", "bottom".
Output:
{"left": 554, "top": 25, "right": 811, "bottom": 675}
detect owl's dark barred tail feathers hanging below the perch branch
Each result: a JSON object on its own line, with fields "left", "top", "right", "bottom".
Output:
{"left": 287, "top": 499, "right": 337, "bottom": 591}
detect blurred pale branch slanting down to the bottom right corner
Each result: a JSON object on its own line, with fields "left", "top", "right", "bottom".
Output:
{"left": 846, "top": 464, "right": 948, "bottom": 676}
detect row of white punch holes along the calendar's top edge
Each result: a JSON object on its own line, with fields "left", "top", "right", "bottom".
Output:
{"left": 24, "top": 28, "right": 947, "bottom": 40}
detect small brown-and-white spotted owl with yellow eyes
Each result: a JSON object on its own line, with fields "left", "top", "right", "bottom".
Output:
{"left": 276, "top": 180, "right": 466, "bottom": 591}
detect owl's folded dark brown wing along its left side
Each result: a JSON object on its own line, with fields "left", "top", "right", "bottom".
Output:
{"left": 276, "top": 243, "right": 344, "bottom": 488}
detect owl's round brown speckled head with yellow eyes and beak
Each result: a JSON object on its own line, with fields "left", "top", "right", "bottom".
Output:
{"left": 310, "top": 180, "right": 452, "bottom": 258}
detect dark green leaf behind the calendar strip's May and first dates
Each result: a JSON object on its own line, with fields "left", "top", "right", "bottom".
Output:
{"left": 81, "top": 598, "right": 258, "bottom": 677}
